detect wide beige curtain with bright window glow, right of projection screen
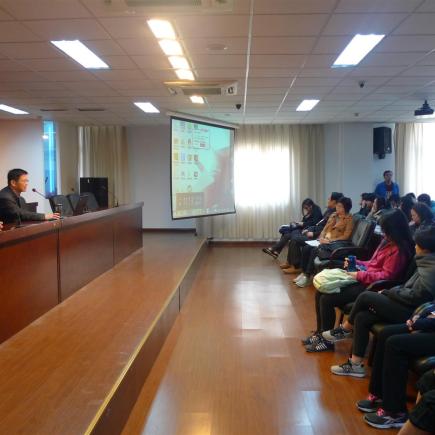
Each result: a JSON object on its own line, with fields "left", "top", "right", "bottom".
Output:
{"left": 209, "top": 125, "right": 324, "bottom": 240}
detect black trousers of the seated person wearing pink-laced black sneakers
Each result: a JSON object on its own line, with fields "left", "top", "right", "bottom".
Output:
{"left": 369, "top": 323, "right": 435, "bottom": 413}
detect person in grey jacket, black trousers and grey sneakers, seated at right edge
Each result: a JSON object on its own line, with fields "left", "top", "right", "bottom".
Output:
{"left": 328, "top": 227, "right": 435, "bottom": 377}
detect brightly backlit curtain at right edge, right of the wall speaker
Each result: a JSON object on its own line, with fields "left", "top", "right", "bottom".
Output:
{"left": 394, "top": 123, "right": 435, "bottom": 196}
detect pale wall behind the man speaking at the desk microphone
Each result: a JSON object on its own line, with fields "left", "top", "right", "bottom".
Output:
{"left": 0, "top": 120, "right": 51, "bottom": 213}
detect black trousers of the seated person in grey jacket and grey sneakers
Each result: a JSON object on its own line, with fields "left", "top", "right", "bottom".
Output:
{"left": 349, "top": 291, "right": 414, "bottom": 358}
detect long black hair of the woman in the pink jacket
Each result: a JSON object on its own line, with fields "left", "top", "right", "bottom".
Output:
{"left": 379, "top": 209, "right": 415, "bottom": 258}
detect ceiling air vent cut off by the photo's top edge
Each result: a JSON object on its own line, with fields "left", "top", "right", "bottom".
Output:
{"left": 104, "top": 0, "right": 234, "bottom": 14}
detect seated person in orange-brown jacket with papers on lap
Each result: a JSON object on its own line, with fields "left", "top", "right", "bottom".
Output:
{"left": 293, "top": 196, "right": 353, "bottom": 287}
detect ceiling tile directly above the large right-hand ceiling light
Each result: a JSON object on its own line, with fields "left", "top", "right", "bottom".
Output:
{"left": 323, "top": 14, "right": 406, "bottom": 35}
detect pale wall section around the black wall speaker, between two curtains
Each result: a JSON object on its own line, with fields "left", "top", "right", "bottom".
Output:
{"left": 325, "top": 123, "right": 394, "bottom": 212}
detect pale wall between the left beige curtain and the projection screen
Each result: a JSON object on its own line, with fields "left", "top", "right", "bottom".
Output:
{"left": 127, "top": 125, "right": 195, "bottom": 228}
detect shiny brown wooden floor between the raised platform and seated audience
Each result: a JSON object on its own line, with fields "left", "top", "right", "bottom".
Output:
{"left": 123, "top": 247, "right": 397, "bottom": 435}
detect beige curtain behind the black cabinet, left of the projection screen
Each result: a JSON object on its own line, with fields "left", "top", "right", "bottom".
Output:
{"left": 79, "top": 125, "right": 130, "bottom": 205}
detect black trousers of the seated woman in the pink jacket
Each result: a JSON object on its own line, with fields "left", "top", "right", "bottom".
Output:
{"left": 315, "top": 282, "right": 366, "bottom": 332}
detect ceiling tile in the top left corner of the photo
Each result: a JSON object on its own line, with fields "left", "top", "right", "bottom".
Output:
{"left": 1, "top": 0, "right": 91, "bottom": 20}
